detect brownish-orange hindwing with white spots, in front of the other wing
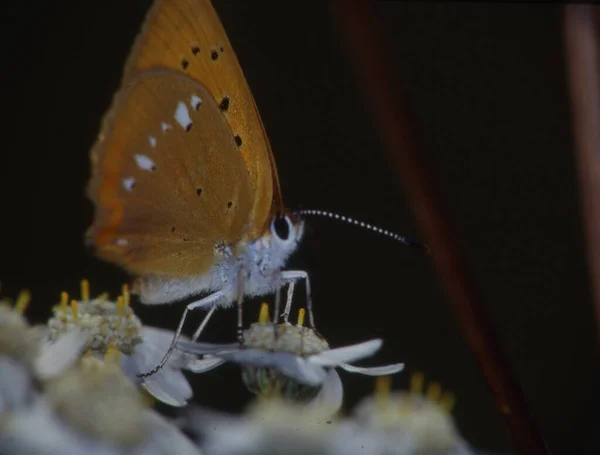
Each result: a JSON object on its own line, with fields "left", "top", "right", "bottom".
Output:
{"left": 89, "top": 70, "right": 253, "bottom": 276}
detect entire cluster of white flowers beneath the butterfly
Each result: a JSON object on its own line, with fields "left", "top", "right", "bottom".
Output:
{"left": 0, "top": 280, "right": 488, "bottom": 455}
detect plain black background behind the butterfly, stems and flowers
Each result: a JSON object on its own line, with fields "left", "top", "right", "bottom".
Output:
{"left": 0, "top": 0, "right": 600, "bottom": 454}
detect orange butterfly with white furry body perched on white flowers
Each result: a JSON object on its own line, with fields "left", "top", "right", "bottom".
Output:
{"left": 86, "top": 0, "right": 308, "bottom": 372}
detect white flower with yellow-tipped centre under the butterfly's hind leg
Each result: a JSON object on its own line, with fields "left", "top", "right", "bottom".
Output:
{"left": 48, "top": 281, "right": 192, "bottom": 406}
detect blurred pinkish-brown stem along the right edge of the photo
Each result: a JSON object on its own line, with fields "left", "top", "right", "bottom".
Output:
{"left": 564, "top": 5, "right": 600, "bottom": 350}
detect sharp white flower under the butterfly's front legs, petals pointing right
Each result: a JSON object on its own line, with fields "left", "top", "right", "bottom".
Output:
{"left": 177, "top": 304, "right": 404, "bottom": 409}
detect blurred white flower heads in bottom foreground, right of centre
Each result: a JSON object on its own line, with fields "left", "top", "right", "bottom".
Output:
{"left": 183, "top": 377, "right": 480, "bottom": 455}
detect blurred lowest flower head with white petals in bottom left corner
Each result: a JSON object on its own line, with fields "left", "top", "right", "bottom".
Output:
{"left": 0, "top": 355, "right": 201, "bottom": 455}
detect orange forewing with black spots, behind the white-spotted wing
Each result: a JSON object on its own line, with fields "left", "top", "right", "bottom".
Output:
{"left": 123, "top": 0, "right": 283, "bottom": 239}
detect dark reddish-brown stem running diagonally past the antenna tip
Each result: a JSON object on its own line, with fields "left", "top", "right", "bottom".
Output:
{"left": 331, "top": 0, "right": 548, "bottom": 455}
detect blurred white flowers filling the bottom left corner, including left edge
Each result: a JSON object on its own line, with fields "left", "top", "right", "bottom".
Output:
{"left": 0, "top": 294, "right": 201, "bottom": 455}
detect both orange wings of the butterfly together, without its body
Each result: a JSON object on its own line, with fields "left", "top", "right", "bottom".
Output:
{"left": 88, "top": 0, "right": 283, "bottom": 276}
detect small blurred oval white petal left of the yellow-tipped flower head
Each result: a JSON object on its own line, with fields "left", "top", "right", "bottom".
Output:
{"left": 35, "top": 328, "right": 89, "bottom": 379}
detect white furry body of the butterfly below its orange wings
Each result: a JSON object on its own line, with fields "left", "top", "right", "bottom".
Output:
{"left": 135, "top": 221, "right": 304, "bottom": 307}
